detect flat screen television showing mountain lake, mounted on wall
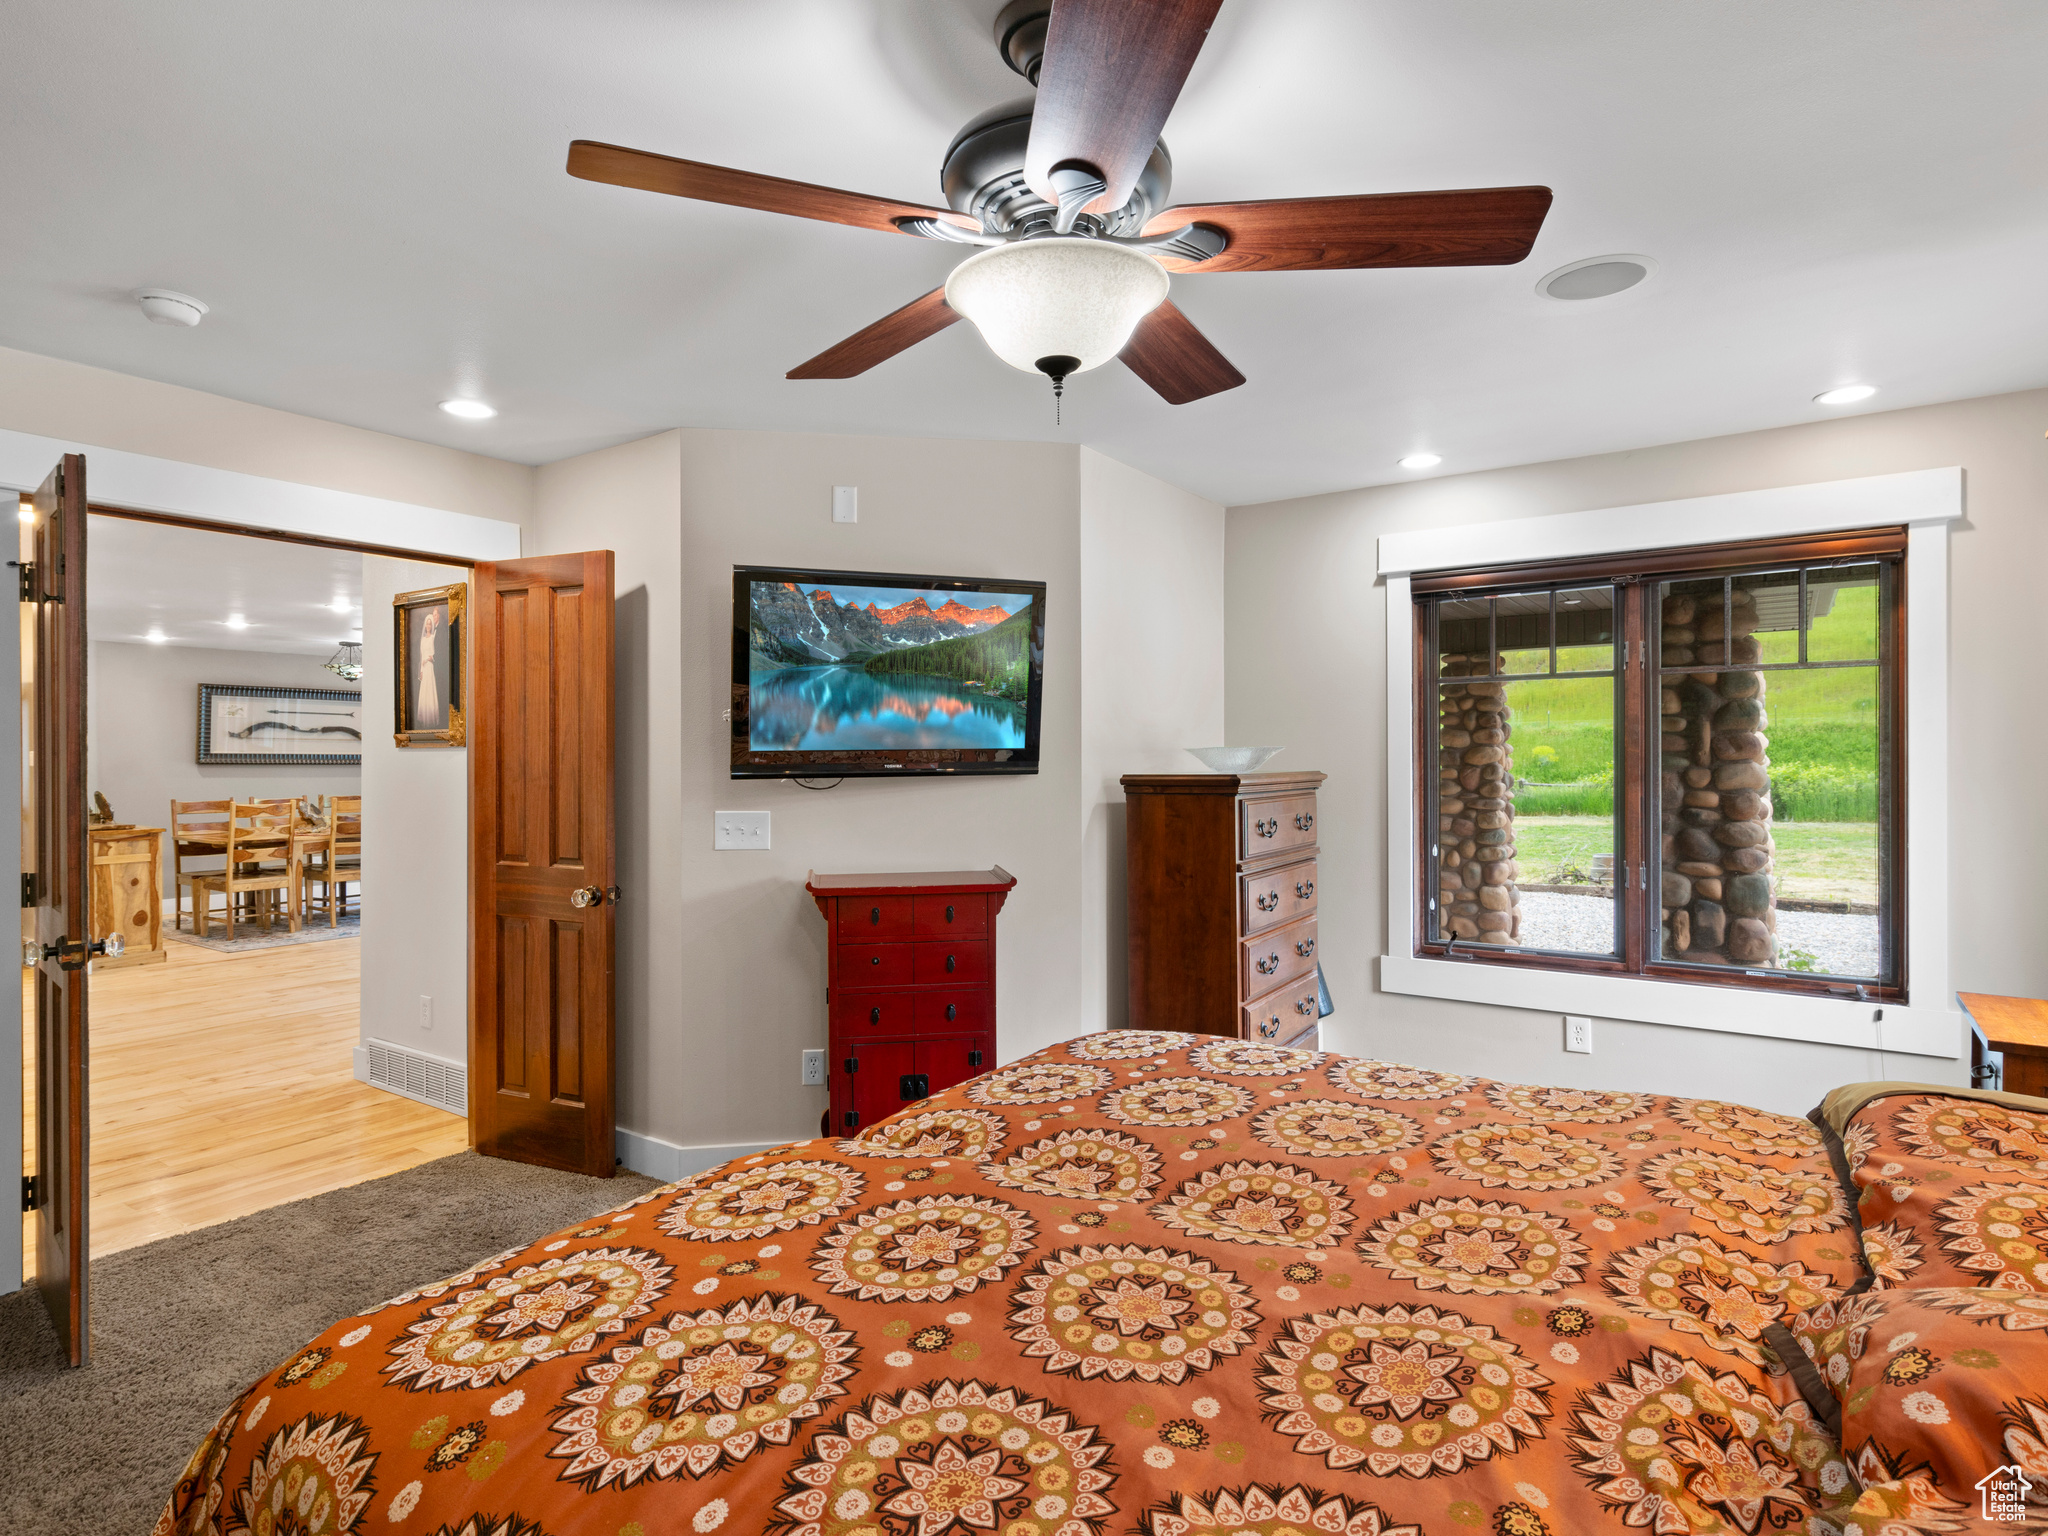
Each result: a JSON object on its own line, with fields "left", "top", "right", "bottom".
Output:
{"left": 731, "top": 565, "right": 1044, "bottom": 778}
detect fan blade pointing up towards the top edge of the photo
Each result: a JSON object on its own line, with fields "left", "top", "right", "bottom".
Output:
{"left": 1024, "top": 0, "right": 1223, "bottom": 213}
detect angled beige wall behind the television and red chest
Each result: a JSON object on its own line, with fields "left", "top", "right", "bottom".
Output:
{"left": 528, "top": 430, "right": 1223, "bottom": 1167}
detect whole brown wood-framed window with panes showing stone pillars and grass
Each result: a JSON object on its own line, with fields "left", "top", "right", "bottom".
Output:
{"left": 1413, "top": 528, "right": 1907, "bottom": 999}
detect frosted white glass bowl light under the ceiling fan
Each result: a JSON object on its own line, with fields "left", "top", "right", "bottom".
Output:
{"left": 946, "top": 238, "right": 1169, "bottom": 377}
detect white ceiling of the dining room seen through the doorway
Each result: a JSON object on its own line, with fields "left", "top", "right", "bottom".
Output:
{"left": 86, "top": 516, "right": 362, "bottom": 659}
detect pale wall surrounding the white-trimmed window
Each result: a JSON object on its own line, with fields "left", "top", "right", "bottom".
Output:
{"left": 1227, "top": 391, "right": 2048, "bottom": 1114}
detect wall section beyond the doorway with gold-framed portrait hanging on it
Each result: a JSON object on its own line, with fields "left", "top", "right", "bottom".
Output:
{"left": 356, "top": 555, "right": 469, "bottom": 1077}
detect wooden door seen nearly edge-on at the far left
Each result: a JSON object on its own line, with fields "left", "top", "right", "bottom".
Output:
{"left": 23, "top": 453, "right": 90, "bottom": 1366}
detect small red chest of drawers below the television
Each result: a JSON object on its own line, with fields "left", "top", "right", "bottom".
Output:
{"left": 803, "top": 866, "right": 1018, "bottom": 1137}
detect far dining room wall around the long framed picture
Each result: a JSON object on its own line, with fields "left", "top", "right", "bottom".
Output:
{"left": 86, "top": 641, "right": 362, "bottom": 901}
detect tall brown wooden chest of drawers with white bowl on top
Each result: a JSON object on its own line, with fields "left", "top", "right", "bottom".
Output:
{"left": 1122, "top": 774, "right": 1323, "bottom": 1047}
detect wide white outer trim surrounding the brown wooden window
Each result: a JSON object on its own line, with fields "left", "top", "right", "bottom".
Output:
{"left": 1372, "top": 465, "right": 1968, "bottom": 1075}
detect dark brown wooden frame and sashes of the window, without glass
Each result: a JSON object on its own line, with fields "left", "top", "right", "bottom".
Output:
{"left": 1409, "top": 524, "right": 1911, "bottom": 1004}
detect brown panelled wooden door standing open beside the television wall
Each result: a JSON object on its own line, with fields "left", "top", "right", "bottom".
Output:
{"left": 469, "top": 549, "right": 618, "bottom": 1178}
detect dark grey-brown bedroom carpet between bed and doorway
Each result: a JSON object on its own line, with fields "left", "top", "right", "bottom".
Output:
{"left": 0, "top": 1153, "right": 655, "bottom": 1536}
